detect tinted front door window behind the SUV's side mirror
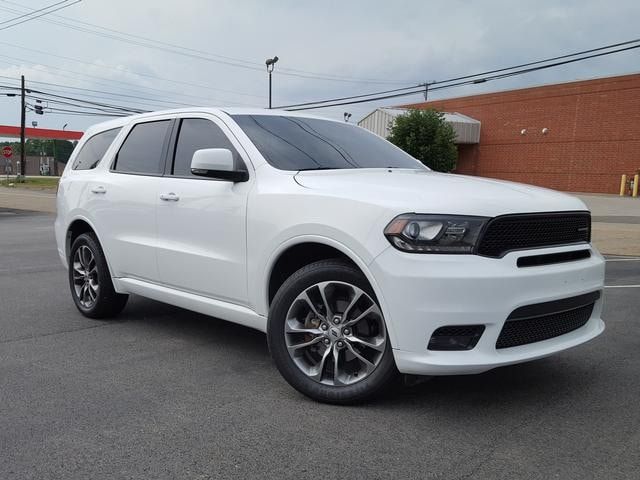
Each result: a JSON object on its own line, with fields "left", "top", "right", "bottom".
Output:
{"left": 171, "top": 118, "right": 246, "bottom": 178}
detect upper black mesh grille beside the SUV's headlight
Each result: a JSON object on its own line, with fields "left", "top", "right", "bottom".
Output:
{"left": 477, "top": 212, "right": 591, "bottom": 258}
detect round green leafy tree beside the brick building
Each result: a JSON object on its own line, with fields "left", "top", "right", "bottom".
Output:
{"left": 387, "top": 110, "right": 458, "bottom": 172}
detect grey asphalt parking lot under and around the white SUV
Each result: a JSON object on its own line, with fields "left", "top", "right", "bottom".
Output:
{"left": 0, "top": 210, "right": 640, "bottom": 479}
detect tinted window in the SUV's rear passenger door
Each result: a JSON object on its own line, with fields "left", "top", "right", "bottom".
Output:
{"left": 114, "top": 120, "right": 171, "bottom": 175}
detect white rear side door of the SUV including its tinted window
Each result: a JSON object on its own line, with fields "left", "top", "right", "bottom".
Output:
{"left": 91, "top": 119, "right": 173, "bottom": 282}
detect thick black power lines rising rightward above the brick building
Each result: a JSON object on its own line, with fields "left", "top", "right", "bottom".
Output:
{"left": 276, "top": 39, "right": 640, "bottom": 111}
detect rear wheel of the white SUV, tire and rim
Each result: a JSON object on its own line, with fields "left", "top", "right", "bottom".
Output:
{"left": 69, "top": 233, "right": 129, "bottom": 318}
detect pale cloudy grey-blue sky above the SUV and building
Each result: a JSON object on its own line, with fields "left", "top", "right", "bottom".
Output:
{"left": 0, "top": 0, "right": 640, "bottom": 130}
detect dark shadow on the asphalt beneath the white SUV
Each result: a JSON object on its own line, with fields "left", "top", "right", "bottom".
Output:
{"left": 117, "top": 296, "right": 599, "bottom": 410}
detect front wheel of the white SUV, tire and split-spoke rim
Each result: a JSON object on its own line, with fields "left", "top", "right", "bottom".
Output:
{"left": 267, "top": 259, "right": 398, "bottom": 404}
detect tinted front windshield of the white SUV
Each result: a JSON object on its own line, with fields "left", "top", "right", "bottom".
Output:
{"left": 232, "top": 115, "right": 425, "bottom": 170}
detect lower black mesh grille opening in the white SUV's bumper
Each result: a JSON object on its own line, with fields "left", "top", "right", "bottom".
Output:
{"left": 496, "top": 292, "right": 600, "bottom": 348}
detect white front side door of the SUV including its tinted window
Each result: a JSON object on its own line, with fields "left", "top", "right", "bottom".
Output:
{"left": 157, "top": 115, "right": 253, "bottom": 305}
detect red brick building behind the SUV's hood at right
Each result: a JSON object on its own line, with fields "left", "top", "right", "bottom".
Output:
{"left": 404, "top": 74, "right": 640, "bottom": 193}
